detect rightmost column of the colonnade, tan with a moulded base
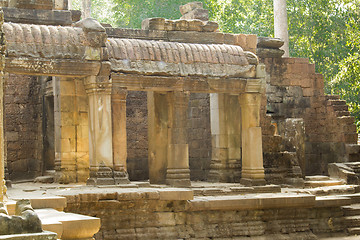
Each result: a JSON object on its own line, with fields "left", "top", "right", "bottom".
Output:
{"left": 239, "top": 93, "right": 265, "bottom": 185}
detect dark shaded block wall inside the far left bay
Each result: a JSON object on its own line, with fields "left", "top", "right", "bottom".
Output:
{"left": 4, "top": 74, "right": 43, "bottom": 180}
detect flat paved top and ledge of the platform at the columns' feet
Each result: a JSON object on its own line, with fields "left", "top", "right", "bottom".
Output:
{"left": 7, "top": 182, "right": 360, "bottom": 240}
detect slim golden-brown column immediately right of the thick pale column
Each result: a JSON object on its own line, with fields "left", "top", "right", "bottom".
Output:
{"left": 111, "top": 87, "right": 130, "bottom": 184}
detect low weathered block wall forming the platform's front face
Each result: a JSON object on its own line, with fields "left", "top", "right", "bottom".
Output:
{"left": 65, "top": 190, "right": 344, "bottom": 240}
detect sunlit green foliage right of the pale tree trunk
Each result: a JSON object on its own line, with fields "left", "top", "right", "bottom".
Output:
{"left": 288, "top": 0, "right": 351, "bottom": 93}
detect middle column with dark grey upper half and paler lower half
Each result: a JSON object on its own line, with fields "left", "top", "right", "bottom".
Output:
{"left": 166, "top": 92, "right": 191, "bottom": 187}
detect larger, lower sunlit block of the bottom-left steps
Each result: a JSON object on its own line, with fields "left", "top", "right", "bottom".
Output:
{"left": 35, "top": 208, "right": 101, "bottom": 239}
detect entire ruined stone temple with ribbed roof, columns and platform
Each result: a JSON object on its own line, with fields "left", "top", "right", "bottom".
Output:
{"left": 0, "top": 0, "right": 360, "bottom": 240}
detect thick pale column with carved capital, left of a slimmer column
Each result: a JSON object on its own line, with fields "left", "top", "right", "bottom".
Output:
{"left": 84, "top": 76, "right": 115, "bottom": 185}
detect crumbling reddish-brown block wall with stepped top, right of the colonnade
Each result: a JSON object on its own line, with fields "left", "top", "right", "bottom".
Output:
{"left": 263, "top": 58, "right": 357, "bottom": 175}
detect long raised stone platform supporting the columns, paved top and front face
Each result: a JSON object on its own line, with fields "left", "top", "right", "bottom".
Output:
{"left": 4, "top": 182, "right": 360, "bottom": 240}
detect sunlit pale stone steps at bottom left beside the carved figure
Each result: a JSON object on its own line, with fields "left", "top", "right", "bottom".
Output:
{"left": 6, "top": 196, "right": 101, "bottom": 240}
